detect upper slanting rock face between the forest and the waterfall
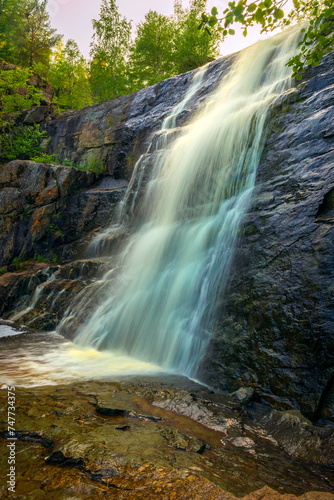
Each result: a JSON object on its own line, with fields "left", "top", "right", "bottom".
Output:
{"left": 46, "top": 56, "right": 233, "bottom": 179}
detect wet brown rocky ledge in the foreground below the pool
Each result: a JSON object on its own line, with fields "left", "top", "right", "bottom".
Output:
{"left": 0, "top": 376, "right": 334, "bottom": 500}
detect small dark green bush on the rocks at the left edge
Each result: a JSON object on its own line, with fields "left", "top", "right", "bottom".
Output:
{"left": 0, "top": 124, "right": 45, "bottom": 160}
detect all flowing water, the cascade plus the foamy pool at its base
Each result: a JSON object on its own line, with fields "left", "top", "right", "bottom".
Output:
{"left": 0, "top": 29, "right": 298, "bottom": 386}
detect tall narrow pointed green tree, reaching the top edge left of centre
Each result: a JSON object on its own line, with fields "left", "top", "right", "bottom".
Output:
{"left": 90, "top": 0, "right": 131, "bottom": 101}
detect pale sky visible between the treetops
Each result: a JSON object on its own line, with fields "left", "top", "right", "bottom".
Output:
{"left": 48, "top": 0, "right": 290, "bottom": 59}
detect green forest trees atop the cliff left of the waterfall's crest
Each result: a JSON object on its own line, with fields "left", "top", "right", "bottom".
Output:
{"left": 0, "top": 0, "right": 220, "bottom": 110}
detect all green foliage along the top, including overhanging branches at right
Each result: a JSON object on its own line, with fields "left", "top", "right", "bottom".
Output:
{"left": 0, "top": 0, "right": 334, "bottom": 112}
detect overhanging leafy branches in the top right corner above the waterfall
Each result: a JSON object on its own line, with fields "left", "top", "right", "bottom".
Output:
{"left": 200, "top": 0, "right": 334, "bottom": 80}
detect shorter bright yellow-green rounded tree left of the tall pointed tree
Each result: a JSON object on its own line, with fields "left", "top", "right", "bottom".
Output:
{"left": 49, "top": 40, "right": 93, "bottom": 109}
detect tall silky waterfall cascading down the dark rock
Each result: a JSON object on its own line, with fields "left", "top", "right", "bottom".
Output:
{"left": 67, "top": 28, "right": 299, "bottom": 376}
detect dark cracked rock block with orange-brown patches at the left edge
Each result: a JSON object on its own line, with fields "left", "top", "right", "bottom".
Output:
{"left": 0, "top": 160, "right": 127, "bottom": 265}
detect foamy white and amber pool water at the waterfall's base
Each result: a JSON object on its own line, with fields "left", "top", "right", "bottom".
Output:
{"left": 0, "top": 332, "right": 161, "bottom": 388}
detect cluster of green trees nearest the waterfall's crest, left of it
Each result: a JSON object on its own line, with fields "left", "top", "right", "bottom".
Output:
{"left": 130, "top": 0, "right": 220, "bottom": 90}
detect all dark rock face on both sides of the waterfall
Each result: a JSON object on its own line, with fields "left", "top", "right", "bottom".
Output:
{"left": 0, "top": 47, "right": 334, "bottom": 420}
